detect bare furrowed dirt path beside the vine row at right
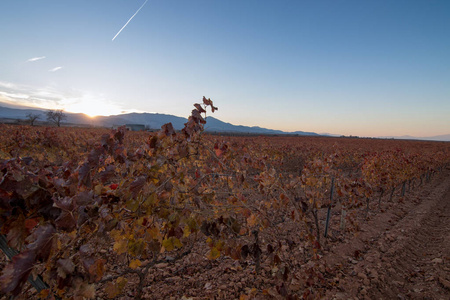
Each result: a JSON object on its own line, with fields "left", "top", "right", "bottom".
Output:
{"left": 324, "top": 169, "right": 450, "bottom": 299}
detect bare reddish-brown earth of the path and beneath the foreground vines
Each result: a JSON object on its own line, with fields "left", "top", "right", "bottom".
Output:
{"left": 0, "top": 168, "right": 450, "bottom": 299}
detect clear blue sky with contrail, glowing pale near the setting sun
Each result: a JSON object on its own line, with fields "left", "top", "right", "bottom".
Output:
{"left": 0, "top": 0, "right": 450, "bottom": 136}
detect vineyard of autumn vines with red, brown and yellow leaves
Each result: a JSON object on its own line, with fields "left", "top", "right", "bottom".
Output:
{"left": 0, "top": 98, "right": 450, "bottom": 299}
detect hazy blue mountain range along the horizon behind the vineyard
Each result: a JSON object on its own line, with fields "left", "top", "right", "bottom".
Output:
{"left": 0, "top": 103, "right": 450, "bottom": 141}
